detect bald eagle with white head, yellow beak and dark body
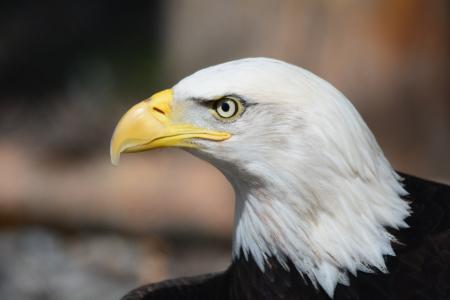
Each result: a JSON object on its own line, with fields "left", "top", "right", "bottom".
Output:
{"left": 111, "top": 58, "right": 450, "bottom": 300}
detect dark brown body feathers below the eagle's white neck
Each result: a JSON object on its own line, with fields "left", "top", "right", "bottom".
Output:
{"left": 123, "top": 174, "right": 450, "bottom": 300}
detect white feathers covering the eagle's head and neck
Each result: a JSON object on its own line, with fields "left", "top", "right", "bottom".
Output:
{"left": 173, "top": 58, "right": 409, "bottom": 297}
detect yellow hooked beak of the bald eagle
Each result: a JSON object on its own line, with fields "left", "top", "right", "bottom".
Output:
{"left": 110, "top": 89, "right": 231, "bottom": 165}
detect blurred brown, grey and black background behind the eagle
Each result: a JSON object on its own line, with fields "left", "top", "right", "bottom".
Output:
{"left": 0, "top": 0, "right": 450, "bottom": 300}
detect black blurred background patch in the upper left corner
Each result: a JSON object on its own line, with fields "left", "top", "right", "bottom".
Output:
{"left": 0, "top": 1, "right": 162, "bottom": 98}
